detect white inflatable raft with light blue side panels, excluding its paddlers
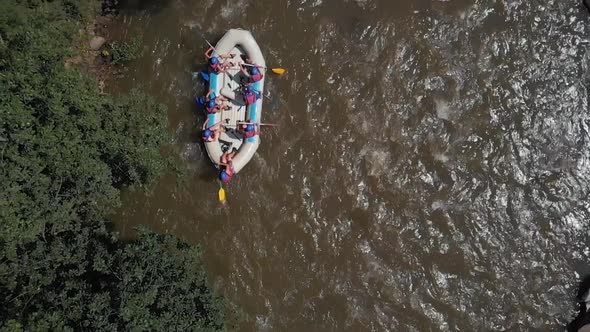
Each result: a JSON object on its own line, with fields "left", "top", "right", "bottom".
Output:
{"left": 205, "top": 29, "right": 266, "bottom": 173}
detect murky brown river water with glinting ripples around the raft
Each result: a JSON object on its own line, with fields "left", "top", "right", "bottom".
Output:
{"left": 109, "top": 0, "right": 590, "bottom": 331}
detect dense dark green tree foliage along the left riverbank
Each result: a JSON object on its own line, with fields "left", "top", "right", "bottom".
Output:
{"left": 0, "top": 0, "right": 224, "bottom": 331}
